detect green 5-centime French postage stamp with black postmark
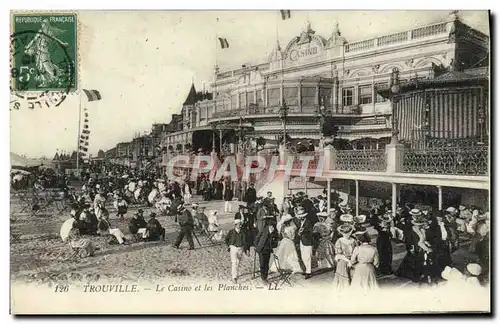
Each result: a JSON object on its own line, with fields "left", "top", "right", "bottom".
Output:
{"left": 11, "top": 13, "right": 78, "bottom": 94}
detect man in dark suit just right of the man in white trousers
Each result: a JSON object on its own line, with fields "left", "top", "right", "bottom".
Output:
{"left": 254, "top": 217, "right": 279, "bottom": 284}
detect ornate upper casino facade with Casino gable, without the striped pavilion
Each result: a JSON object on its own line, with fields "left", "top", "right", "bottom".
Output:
{"left": 162, "top": 13, "right": 489, "bottom": 154}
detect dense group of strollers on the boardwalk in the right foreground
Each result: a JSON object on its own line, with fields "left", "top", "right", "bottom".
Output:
{"left": 226, "top": 192, "right": 489, "bottom": 289}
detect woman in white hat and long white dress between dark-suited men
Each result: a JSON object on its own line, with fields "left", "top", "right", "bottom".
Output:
{"left": 271, "top": 214, "right": 302, "bottom": 273}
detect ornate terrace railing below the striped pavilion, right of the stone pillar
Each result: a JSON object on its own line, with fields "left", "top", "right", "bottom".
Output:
{"left": 403, "top": 146, "right": 488, "bottom": 175}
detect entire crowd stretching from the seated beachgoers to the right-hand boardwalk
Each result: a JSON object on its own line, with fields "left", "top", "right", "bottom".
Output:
{"left": 20, "top": 161, "right": 490, "bottom": 289}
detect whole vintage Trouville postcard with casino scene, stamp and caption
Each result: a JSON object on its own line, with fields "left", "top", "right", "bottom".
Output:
{"left": 8, "top": 10, "right": 491, "bottom": 314}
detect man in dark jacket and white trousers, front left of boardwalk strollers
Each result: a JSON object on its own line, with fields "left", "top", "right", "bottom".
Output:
{"left": 225, "top": 219, "right": 250, "bottom": 284}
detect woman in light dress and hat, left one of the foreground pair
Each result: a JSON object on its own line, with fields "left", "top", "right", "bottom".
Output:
{"left": 333, "top": 224, "right": 356, "bottom": 289}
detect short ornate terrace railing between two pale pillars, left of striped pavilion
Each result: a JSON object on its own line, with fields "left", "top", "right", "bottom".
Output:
{"left": 332, "top": 150, "right": 387, "bottom": 172}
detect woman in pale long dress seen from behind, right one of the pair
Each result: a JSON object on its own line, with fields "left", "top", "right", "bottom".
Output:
{"left": 351, "top": 233, "right": 379, "bottom": 289}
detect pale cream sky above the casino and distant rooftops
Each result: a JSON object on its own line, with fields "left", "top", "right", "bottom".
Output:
{"left": 10, "top": 10, "right": 489, "bottom": 157}
